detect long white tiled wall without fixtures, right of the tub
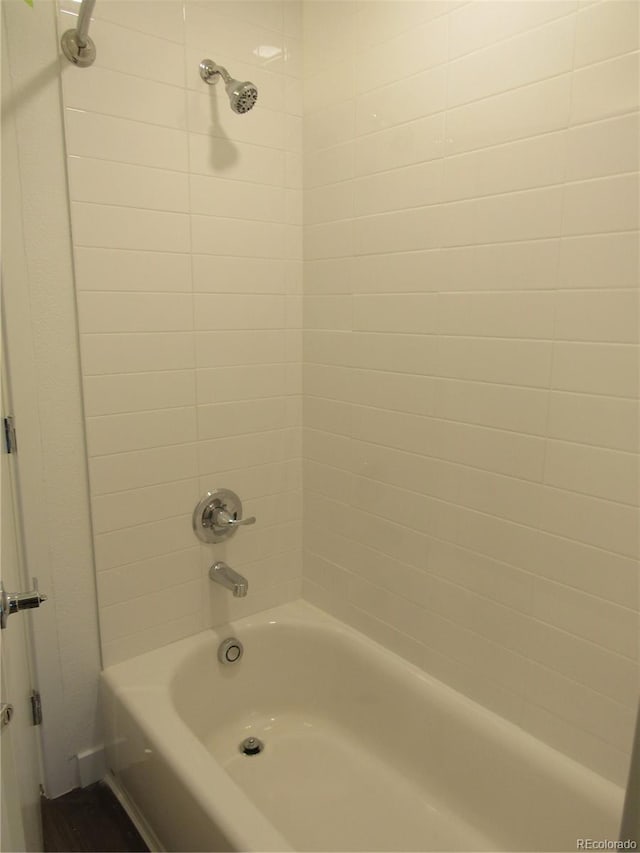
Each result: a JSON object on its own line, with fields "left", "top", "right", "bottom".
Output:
{"left": 303, "top": 0, "right": 639, "bottom": 782}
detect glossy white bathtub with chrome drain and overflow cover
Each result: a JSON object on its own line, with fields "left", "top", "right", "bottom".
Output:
{"left": 101, "top": 602, "right": 623, "bottom": 851}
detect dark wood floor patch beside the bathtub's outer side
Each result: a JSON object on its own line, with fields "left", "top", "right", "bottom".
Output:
{"left": 42, "top": 782, "right": 149, "bottom": 853}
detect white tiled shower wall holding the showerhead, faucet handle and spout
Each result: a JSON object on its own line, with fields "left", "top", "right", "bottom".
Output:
{"left": 59, "top": 0, "right": 302, "bottom": 664}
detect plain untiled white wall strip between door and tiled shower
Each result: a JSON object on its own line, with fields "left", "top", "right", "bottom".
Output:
{"left": 2, "top": 0, "right": 101, "bottom": 796}
